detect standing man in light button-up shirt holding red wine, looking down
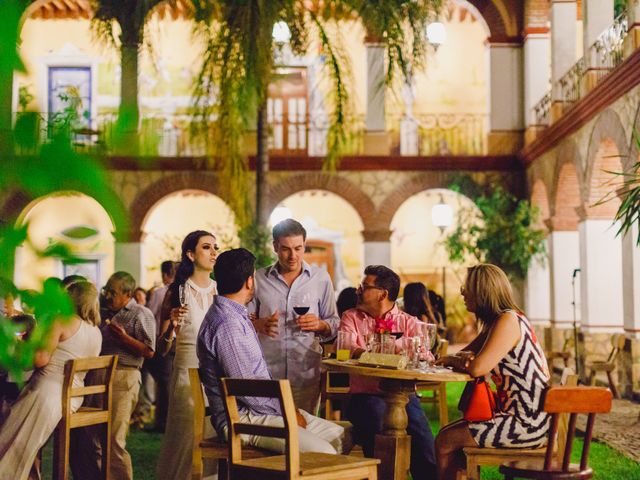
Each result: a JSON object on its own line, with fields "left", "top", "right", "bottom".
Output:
{"left": 249, "top": 219, "right": 340, "bottom": 413}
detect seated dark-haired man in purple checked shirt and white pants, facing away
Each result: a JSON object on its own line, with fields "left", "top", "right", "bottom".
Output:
{"left": 197, "top": 248, "right": 344, "bottom": 453}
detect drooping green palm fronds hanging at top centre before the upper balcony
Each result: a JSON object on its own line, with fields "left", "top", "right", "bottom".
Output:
{"left": 192, "top": 0, "right": 441, "bottom": 227}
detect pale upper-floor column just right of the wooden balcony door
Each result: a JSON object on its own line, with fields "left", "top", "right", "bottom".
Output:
{"left": 364, "top": 38, "right": 391, "bottom": 155}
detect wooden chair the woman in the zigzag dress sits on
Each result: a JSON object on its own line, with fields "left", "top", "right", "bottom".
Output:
{"left": 463, "top": 368, "right": 578, "bottom": 480}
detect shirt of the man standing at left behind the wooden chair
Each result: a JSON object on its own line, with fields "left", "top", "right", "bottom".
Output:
{"left": 100, "top": 298, "right": 156, "bottom": 368}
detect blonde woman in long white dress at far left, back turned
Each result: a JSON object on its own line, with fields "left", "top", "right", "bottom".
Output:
{"left": 0, "top": 281, "right": 102, "bottom": 480}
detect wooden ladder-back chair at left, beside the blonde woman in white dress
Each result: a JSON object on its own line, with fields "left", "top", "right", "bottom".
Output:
{"left": 53, "top": 355, "right": 118, "bottom": 480}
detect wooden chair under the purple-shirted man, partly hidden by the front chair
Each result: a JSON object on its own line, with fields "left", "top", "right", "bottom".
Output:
{"left": 189, "top": 368, "right": 267, "bottom": 480}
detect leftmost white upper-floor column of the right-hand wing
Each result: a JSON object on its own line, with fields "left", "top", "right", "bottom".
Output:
{"left": 524, "top": 27, "right": 551, "bottom": 134}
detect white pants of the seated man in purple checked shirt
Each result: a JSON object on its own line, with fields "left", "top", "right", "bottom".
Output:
{"left": 224, "top": 410, "right": 344, "bottom": 455}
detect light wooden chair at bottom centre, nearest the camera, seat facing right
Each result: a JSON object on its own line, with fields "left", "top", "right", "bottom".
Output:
{"left": 222, "top": 378, "right": 380, "bottom": 480}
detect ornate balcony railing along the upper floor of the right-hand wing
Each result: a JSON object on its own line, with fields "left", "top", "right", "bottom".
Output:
{"left": 533, "top": 12, "right": 628, "bottom": 125}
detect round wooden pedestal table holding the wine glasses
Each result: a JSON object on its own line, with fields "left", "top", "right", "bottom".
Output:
{"left": 322, "top": 359, "right": 471, "bottom": 480}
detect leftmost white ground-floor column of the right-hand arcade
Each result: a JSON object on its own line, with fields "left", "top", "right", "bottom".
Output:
{"left": 524, "top": 239, "right": 551, "bottom": 331}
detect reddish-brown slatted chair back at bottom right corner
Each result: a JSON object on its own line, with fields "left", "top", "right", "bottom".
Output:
{"left": 543, "top": 386, "right": 613, "bottom": 472}
